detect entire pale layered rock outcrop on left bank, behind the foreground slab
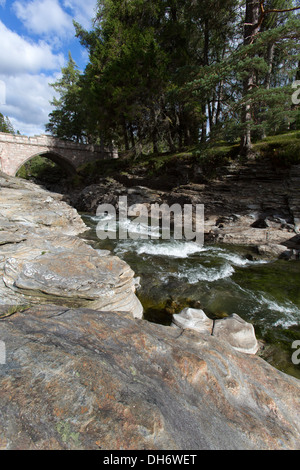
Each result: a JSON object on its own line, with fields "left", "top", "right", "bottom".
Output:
{"left": 0, "top": 175, "right": 143, "bottom": 318}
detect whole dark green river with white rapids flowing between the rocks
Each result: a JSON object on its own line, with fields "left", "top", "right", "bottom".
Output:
{"left": 82, "top": 214, "right": 300, "bottom": 379}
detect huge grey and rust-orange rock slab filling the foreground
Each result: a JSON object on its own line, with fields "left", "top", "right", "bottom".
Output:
{"left": 0, "top": 305, "right": 300, "bottom": 450}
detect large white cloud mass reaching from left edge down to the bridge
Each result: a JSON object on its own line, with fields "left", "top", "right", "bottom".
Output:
{"left": 0, "top": 17, "right": 65, "bottom": 135}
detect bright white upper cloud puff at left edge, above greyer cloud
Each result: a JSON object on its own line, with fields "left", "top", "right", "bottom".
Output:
{"left": 0, "top": 21, "right": 64, "bottom": 75}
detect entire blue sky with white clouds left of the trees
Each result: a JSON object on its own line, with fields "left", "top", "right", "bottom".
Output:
{"left": 0, "top": 0, "right": 97, "bottom": 136}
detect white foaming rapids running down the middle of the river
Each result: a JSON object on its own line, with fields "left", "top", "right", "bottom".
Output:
{"left": 83, "top": 216, "right": 300, "bottom": 336}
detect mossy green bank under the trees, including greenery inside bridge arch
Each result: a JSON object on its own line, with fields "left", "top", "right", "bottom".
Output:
{"left": 18, "top": 131, "right": 300, "bottom": 189}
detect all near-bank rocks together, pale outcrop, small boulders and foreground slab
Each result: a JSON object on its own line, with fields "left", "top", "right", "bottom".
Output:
{"left": 0, "top": 171, "right": 300, "bottom": 450}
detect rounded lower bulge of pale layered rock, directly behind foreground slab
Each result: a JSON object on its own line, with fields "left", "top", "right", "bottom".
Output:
{"left": 0, "top": 235, "right": 143, "bottom": 318}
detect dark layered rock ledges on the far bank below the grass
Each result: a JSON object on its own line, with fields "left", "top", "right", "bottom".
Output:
{"left": 68, "top": 161, "right": 300, "bottom": 259}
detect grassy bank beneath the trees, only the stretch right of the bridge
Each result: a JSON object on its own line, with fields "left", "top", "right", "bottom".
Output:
{"left": 79, "top": 131, "right": 300, "bottom": 184}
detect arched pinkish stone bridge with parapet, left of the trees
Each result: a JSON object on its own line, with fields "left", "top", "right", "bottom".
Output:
{"left": 0, "top": 132, "right": 118, "bottom": 176}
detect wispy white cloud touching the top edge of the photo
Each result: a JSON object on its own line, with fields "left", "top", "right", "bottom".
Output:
{"left": 13, "top": 0, "right": 74, "bottom": 37}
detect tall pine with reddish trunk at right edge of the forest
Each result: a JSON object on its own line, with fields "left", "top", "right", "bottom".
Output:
{"left": 241, "top": 0, "right": 300, "bottom": 156}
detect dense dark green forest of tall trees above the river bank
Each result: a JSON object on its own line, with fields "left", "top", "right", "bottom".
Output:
{"left": 46, "top": 0, "right": 300, "bottom": 158}
